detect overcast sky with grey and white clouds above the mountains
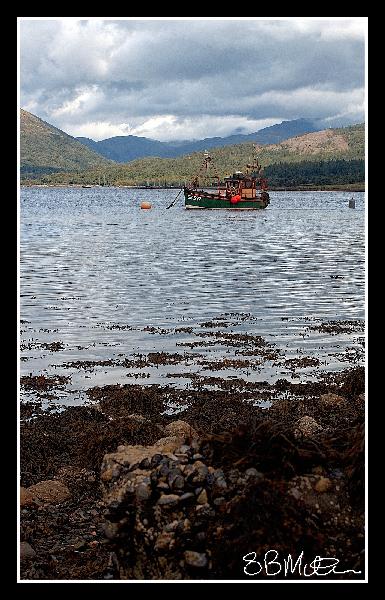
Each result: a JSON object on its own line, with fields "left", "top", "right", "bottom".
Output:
{"left": 20, "top": 17, "right": 366, "bottom": 141}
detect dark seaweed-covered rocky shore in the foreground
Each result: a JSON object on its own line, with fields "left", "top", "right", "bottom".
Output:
{"left": 20, "top": 367, "right": 365, "bottom": 581}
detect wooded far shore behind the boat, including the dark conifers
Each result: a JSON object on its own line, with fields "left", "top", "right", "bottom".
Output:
{"left": 20, "top": 118, "right": 365, "bottom": 187}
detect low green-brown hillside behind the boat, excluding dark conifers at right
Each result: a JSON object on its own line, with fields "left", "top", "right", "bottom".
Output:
{"left": 30, "top": 124, "right": 365, "bottom": 185}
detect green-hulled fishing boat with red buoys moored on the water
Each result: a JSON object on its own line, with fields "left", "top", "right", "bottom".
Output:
{"left": 183, "top": 152, "right": 270, "bottom": 210}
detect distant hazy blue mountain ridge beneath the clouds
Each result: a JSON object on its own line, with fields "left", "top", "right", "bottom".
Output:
{"left": 76, "top": 119, "right": 323, "bottom": 163}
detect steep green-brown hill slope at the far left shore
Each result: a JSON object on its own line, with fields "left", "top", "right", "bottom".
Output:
{"left": 20, "top": 110, "right": 111, "bottom": 177}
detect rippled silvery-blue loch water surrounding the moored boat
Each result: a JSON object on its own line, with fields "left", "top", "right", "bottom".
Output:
{"left": 20, "top": 188, "right": 365, "bottom": 402}
